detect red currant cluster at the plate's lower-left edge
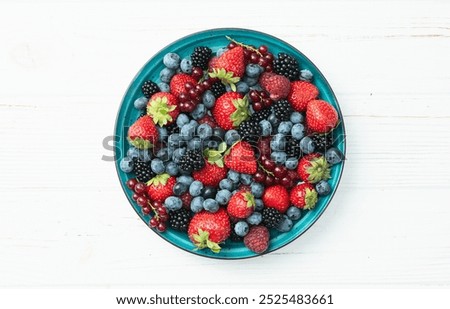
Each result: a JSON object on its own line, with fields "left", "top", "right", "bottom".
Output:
{"left": 126, "top": 178, "right": 169, "bottom": 232}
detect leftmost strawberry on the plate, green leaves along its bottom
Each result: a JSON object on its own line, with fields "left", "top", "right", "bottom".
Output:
{"left": 128, "top": 116, "right": 159, "bottom": 149}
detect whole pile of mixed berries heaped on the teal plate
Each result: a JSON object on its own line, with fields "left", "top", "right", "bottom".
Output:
{"left": 119, "top": 37, "right": 344, "bottom": 254}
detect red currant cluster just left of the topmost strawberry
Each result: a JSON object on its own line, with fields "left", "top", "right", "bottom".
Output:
{"left": 178, "top": 71, "right": 216, "bottom": 113}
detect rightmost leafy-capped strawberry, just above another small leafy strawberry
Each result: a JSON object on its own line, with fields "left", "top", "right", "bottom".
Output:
{"left": 297, "top": 153, "right": 331, "bottom": 183}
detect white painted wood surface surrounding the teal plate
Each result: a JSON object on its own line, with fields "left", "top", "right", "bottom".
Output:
{"left": 0, "top": 0, "right": 450, "bottom": 288}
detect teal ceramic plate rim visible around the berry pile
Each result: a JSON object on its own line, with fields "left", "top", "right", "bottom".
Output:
{"left": 114, "top": 28, "right": 345, "bottom": 259}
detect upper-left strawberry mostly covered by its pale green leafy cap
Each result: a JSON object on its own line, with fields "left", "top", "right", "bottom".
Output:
{"left": 147, "top": 92, "right": 180, "bottom": 127}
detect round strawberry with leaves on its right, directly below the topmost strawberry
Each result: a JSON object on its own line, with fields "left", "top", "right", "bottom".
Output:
{"left": 212, "top": 92, "right": 250, "bottom": 130}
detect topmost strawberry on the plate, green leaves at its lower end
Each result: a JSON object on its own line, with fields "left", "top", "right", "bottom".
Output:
{"left": 209, "top": 46, "right": 245, "bottom": 91}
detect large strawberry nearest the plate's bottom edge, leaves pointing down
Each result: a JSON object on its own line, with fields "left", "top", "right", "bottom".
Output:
{"left": 188, "top": 208, "right": 231, "bottom": 253}
